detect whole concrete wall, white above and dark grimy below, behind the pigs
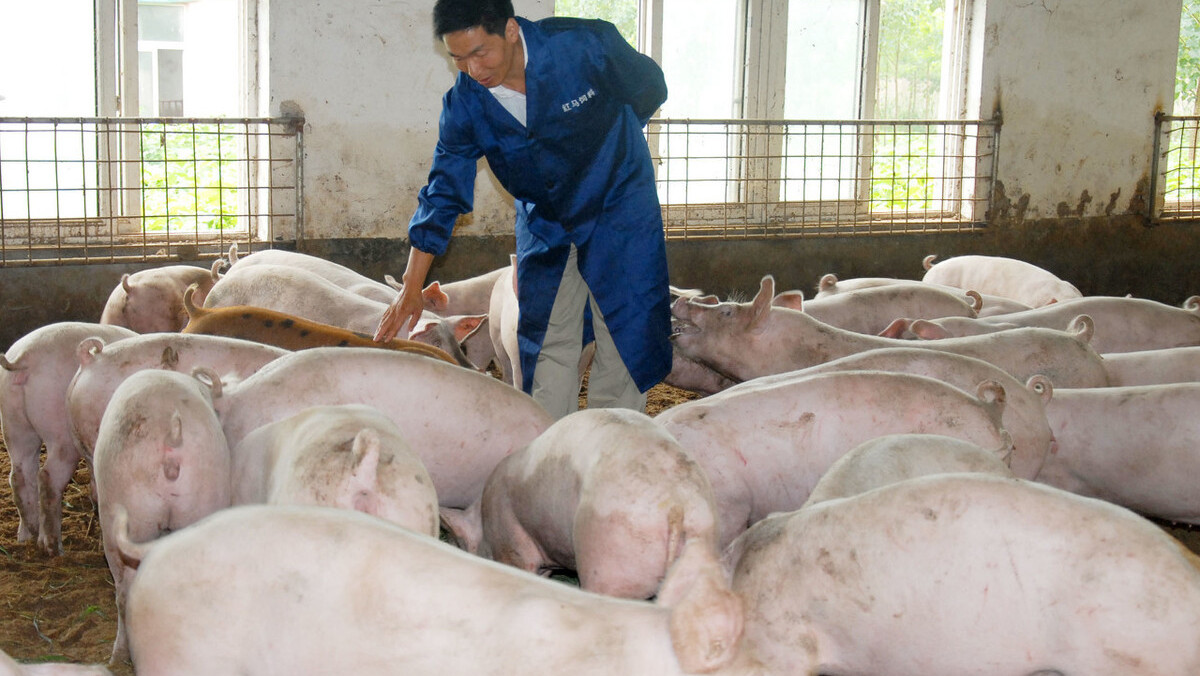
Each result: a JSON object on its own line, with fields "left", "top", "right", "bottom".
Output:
{"left": 0, "top": 0, "right": 1200, "bottom": 346}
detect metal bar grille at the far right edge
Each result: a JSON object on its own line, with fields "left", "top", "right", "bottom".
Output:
{"left": 1147, "top": 113, "right": 1200, "bottom": 222}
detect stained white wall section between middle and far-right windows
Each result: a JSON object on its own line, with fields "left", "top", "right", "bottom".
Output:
{"left": 977, "top": 0, "right": 1182, "bottom": 219}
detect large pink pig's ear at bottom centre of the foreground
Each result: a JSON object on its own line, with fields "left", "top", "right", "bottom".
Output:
{"left": 656, "top": 540, "right": 745, "bottom": 674}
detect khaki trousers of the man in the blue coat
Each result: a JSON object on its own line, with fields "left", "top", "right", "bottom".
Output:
{"left": 533, "top": 245, "right": 646, "bottom": 419}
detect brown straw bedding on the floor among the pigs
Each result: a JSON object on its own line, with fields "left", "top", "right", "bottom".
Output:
{"left": 0, "top": 385, "right": 1200, "bottom": 676}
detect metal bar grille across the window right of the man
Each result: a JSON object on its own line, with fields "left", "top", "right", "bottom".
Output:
{"left": 647, "top": 118, "right": 1001, "bottom": 239}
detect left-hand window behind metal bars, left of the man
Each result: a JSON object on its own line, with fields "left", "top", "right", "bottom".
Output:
{"left": 0, "top": 0, "right": 300, "bottom": 264}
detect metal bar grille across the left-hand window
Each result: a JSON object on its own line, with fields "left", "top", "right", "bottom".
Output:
{"left": 0, "top": 118, "right": 304, "bottom": 267}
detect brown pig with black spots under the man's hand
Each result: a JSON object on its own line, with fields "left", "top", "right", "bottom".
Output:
{"left": 182, "top": 288, "right": 458, "bottom": 369}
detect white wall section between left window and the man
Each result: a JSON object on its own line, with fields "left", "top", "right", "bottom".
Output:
{"left": 268, "top": 0, "right": 553, "bottom": 239}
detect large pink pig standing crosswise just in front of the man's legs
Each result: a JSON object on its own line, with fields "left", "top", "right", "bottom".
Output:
{"left": 216, "top": 347, "right": 552, "bottom": 509}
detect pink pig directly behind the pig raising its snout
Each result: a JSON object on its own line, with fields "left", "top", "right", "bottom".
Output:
{"left": 772, "top": 285, "right": 976, "bottom": 335}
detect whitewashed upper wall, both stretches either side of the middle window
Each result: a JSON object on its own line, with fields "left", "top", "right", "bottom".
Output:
{"left": 268, "top": 0, "right": 1181, "bottom": 239}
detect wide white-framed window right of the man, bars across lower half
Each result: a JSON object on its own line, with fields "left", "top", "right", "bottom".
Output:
{"left": 557, "top": 0, "right": 995, "bottom": 237}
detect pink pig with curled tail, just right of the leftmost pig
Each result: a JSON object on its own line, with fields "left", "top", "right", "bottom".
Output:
{"left": 65, "top": 334, "right": 289, "bottom": 460}
